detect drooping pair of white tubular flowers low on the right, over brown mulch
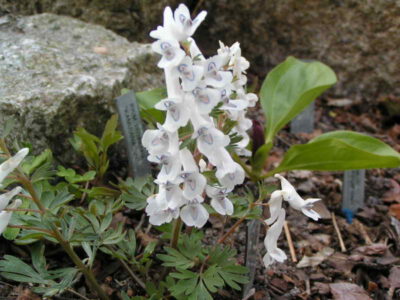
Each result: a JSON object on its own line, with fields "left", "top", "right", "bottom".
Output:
{"left": 263, "top": 174, "right": 321, "bottom": 267}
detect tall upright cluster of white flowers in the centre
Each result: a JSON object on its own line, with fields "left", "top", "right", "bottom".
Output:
{"left": 142, "top": 4, "right": 257, "bottom": 228}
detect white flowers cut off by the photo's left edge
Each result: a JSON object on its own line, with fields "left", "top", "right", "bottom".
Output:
{"left": 0, "top": 148, "right": 29, "bottom": 234}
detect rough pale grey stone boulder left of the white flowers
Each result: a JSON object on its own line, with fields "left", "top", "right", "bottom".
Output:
{"left": 0, "top": 14, "right": 163, "bottom": 158}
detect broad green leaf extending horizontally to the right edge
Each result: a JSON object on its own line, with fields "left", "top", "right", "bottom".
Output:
{"left": 271, "top": 131, "right": 400, "bottom": 174}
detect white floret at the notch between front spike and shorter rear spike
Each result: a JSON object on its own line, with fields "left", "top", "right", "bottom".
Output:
{"left": 204, "top": 55, "right": 233, "bottom": 88}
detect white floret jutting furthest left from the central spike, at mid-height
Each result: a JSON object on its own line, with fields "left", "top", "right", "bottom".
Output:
{"left": 142, "top": 124, "right": 179, "bottom": 155}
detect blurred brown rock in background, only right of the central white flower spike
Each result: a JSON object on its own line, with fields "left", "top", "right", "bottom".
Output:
{"left": 198, "top": 0, "right": 400, "bottom": 101}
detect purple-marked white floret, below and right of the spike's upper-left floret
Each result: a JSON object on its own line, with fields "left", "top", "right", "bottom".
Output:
{"left": 175, "top": 56, "right": 203, "bottom": 92}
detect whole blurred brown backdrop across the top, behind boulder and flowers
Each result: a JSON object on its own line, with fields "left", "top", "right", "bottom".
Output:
{"left": 0, "top": 0, "right": 400, "bottom": 101}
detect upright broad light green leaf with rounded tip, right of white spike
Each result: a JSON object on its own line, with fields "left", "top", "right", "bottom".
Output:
{"left": 260, "top": 57, "right": 336, "bottom": 141}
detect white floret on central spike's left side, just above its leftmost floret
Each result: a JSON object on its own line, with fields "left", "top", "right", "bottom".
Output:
{"left": 155, "top": 98, "right": 190, "bottom": 132}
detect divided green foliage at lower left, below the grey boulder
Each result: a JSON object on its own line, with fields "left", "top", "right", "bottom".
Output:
{"left": 0, "top": 116, "right": 126, "bottom": 299}
